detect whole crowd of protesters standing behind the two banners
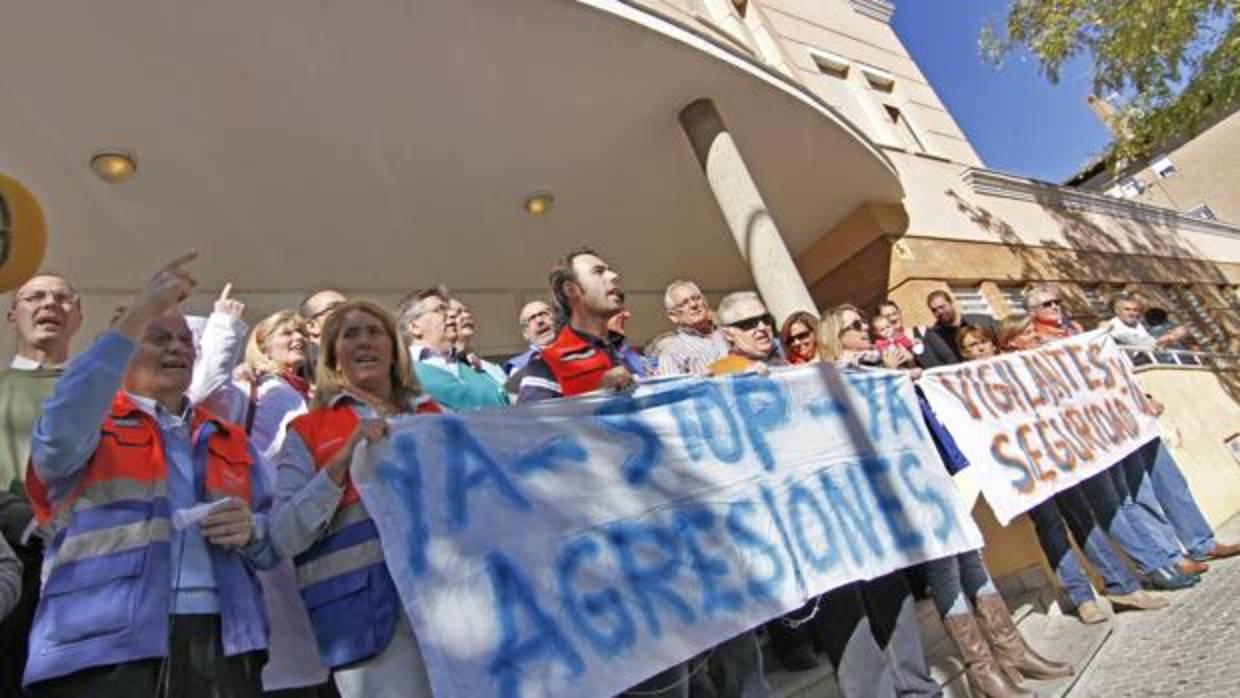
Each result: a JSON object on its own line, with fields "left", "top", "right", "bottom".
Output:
{"left": 0, "top": 248, "right": 1240, "bottom": 698}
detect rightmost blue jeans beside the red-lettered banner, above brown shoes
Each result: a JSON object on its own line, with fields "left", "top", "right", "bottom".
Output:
{"left": 1123, "top": 439, "right": 1216, "bottom": 555}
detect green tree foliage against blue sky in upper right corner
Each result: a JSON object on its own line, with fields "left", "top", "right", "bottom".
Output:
{"left": 980, "top": 0, "right": 1240, "bottom": 164}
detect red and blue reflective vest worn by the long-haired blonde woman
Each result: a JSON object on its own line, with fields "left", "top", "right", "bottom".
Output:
{"left": 289, "top": 397, "right": 440, "bottom": 669}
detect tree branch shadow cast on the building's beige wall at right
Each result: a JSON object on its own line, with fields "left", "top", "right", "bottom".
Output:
{"left": 944, "top": 187, "right": 1240, "bottom": 403}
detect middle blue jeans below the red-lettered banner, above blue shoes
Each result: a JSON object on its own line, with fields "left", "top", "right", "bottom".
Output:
{"left": 1079, "top": 461, "right": 1180, "bottom": 574}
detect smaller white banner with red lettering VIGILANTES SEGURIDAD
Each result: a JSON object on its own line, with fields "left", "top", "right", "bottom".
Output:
{"left": 920, "top": 330, "right": 1158, "bottom": 526}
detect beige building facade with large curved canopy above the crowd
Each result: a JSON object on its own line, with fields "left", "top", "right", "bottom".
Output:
{"left": 0, "top": 0, "right": 1240, "bottom": 580}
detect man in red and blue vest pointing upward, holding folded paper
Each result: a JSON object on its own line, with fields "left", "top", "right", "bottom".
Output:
{"left": 25, "top": 254, "right": 278, "bottom": 698}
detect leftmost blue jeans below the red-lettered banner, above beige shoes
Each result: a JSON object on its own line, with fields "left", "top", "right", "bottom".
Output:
{"left": 1046, "top": 485, "right": 1141, "bottom": 595}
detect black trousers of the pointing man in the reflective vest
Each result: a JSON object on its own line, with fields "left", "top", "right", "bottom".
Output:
{"left": 30, "top": 615, "right": 267, "bottom": 698}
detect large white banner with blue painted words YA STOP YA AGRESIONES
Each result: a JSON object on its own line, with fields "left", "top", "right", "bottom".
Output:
{"left": 353, "top": 366, "right": 981, "bottom": 698}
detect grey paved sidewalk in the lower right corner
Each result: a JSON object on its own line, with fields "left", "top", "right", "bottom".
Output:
{"left": 1070, "top": 517, "right": 1240, "bottom": 698}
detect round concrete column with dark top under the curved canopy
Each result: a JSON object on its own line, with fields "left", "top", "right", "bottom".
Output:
{"left": 680, "top": 99, "right": 818, "bottom": 322}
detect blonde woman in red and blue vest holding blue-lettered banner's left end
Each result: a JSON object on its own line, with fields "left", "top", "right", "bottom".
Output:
{"left": 272, "top": 300, "right": 440, "bottom": 698}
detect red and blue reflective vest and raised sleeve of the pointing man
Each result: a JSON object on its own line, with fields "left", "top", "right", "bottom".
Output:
{"left": 24, "top": 334, "right": 277, "bottom": 684}
